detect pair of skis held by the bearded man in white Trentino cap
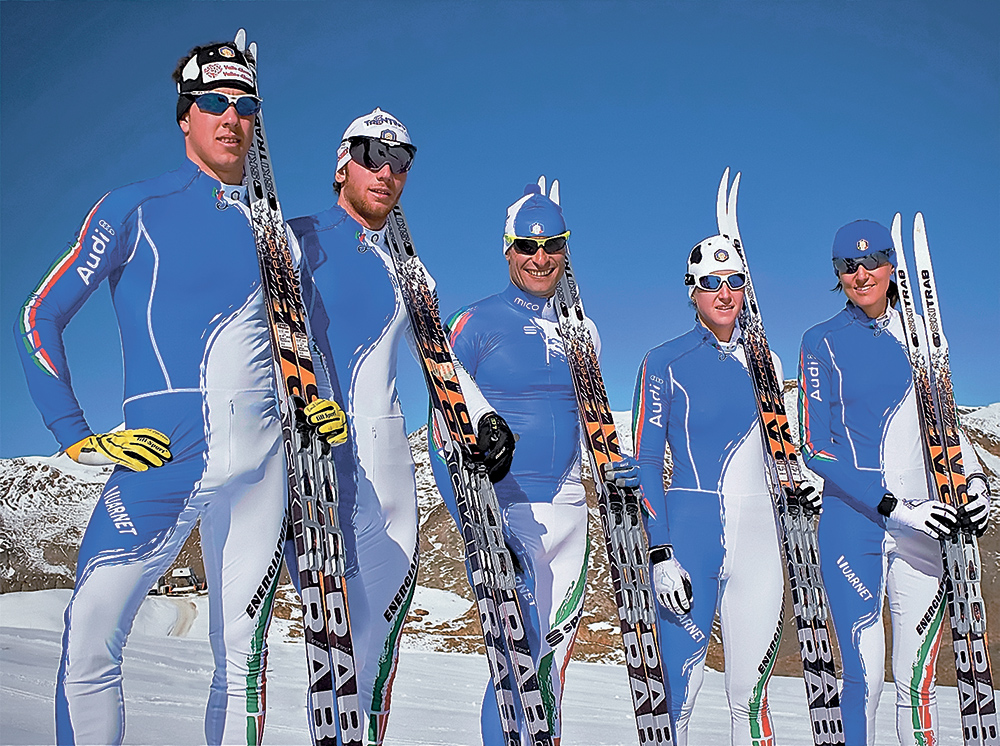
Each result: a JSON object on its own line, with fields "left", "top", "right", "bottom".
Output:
{"left": 386, "top": 205, "right": 552, "bottom": 746}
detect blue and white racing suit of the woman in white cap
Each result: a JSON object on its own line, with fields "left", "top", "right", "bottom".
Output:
{"left": 632, "top": 321, "right": 784, "bottom": 746}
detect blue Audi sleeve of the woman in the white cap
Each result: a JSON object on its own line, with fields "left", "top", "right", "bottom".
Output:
{"left": 632, "top": 351, "right": 671, "bottom": 546}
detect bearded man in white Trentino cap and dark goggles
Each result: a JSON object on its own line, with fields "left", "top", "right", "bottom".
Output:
{"left": 288, "top": 108, "right": 514, "bottom": 744}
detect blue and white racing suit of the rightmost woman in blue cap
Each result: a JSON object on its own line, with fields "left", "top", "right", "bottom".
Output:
{"left": 799, "top": 303, "right": 979, "bottom": 746}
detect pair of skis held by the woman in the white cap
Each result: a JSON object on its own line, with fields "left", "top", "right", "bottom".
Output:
{"left": 716, "top": 168, "right": 844, "bottom": 746}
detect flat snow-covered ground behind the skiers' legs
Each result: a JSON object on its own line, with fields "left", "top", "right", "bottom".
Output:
{"left": 0, "top": 589, "right": 962, "bottom": 746}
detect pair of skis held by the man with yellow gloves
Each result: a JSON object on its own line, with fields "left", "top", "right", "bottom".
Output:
{"left": 236, "top": 29, "right": 363, "bottom": 746}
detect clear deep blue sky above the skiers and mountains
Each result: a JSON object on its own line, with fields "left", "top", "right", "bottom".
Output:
{"left": 0, "top": 0, "right": 1000, "bottom": 457}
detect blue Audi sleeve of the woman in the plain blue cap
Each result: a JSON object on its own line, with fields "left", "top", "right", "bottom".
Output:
{"left": 799, "top": 332, "right": 886, "bottom": 516}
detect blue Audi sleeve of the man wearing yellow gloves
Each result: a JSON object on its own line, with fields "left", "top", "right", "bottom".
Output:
{"left": 14, "top": 195, "right": 130, "bottom": 449}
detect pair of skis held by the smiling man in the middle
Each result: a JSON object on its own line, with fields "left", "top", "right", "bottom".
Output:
{"left": 538, "top": 176, "right": 673, "bottom": 746}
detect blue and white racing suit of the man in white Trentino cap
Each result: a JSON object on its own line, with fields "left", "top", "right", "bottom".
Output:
{"left": 288, "top": 205, "right": 486, "bottom": 744}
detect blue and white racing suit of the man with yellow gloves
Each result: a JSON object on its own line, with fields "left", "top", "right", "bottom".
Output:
{"left": 15, "top": 162, "right": 285, "bottom": 744}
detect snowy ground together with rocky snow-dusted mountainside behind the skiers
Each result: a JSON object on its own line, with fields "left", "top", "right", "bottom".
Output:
{"left": 0, "top": 401, "right": 1000, "bottom": 746}
